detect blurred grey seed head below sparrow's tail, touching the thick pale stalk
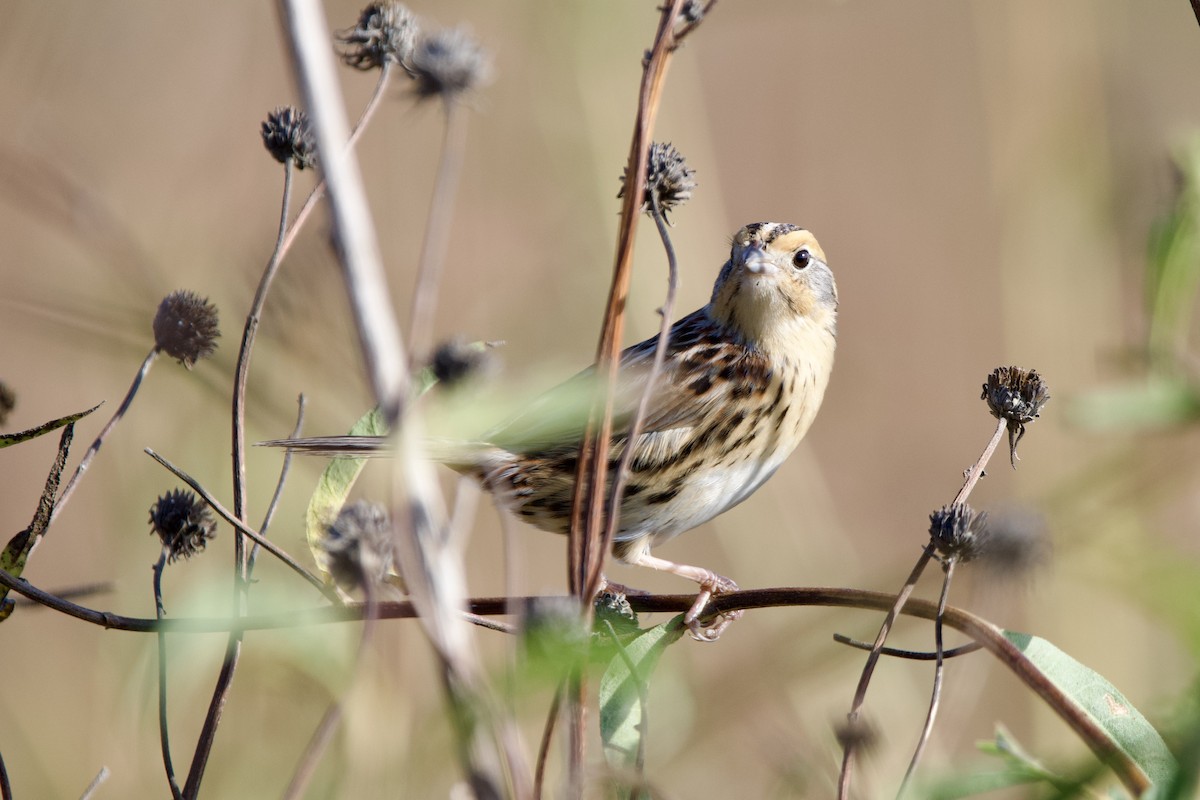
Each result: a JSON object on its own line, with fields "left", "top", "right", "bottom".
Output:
{"left": 320, "top": 500, "right": 394, "bottom": 590}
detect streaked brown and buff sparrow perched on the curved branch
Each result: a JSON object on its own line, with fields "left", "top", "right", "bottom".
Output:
{"left": 264, "top": 222, "right": 838, "bottom": 640}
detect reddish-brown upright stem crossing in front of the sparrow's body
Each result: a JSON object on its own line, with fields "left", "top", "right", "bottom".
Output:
{"left": 568, "top": 0, "right": 684, "bottom": 798}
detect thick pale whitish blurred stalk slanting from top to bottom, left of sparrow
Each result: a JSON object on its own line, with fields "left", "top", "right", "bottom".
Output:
{"left": 280, "top": 0, "right": 527, "bottom": 796}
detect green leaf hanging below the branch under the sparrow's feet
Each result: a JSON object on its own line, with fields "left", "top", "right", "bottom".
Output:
{"left": 600, "top": 614, "right": 685, "bottom": 769}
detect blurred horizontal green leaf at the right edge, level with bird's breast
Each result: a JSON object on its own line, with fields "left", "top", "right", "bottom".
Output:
{"left": 1068, "top": 375, "right": 1200, "bottom": 432}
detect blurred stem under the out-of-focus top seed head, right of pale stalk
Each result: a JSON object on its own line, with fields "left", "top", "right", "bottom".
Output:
{"left": 408, "top": 95, "right": 468, "bottom": 363}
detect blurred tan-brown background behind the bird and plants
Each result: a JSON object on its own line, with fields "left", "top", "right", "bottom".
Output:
{"left": 0, "top": 0, "right": 1200, "bottom": 798}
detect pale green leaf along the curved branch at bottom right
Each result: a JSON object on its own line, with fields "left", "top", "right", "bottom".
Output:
{"left": 1004, "top": 631, "right": 1178, "bottom": 784}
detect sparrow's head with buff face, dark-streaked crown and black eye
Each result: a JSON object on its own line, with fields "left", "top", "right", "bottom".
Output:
{"left": 709, "top": 222, "right": 838, "bottom": 348}
